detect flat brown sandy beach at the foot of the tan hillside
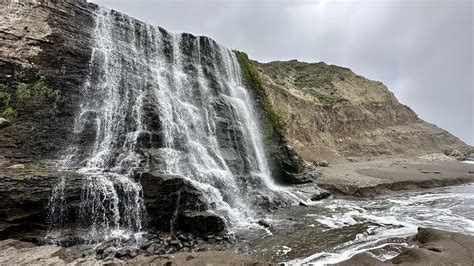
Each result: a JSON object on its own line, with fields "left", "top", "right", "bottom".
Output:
{"left": 315, "top": 154, "right": 474, "bottom": 197}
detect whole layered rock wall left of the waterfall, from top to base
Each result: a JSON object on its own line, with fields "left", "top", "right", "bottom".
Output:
{"left": 0, "top": 1, "right": 94, "bottom": 238}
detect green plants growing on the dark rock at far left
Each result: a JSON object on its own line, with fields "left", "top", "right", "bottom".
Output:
{"left": 0, "top": 74, "right": 61, "bottom": 117}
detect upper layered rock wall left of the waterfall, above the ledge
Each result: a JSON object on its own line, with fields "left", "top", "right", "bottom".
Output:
{"left": 0, "top": 1, "right": 94, "bottom": 165}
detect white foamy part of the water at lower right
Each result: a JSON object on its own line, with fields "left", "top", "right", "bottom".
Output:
{"left": 287, "top": 184, "right": 474, "bottom": 265}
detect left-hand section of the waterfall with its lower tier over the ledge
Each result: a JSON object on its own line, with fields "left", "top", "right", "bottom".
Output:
{"left": 49, "top": 7, "right": 149, "bottom": 239}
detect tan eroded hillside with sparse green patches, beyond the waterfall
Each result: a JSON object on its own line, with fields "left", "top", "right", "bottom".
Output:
{"left": 253, "top": 60, "right": 469, "bottom": 161}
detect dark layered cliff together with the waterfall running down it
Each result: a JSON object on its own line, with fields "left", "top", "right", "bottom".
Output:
{"left": 0, "top": 0, "right": 306, "bottom": 241}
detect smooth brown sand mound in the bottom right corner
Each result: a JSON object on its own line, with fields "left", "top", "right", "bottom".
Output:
{"left": 337, "top": 228, "right": 474, "bottom": 266}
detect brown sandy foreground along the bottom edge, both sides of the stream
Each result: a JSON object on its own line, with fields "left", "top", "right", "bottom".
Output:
{"left": 0, "top": 227, "right": 474, "bottom": 266}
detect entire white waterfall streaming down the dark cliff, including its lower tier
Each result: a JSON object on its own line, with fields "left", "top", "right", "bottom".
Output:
{"left": 49, "top": 8, "right": 294, "bottom": 239}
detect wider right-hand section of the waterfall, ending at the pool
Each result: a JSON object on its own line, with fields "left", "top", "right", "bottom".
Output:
{"left": 153, "top": 31, "right": 286, "bottom": 222}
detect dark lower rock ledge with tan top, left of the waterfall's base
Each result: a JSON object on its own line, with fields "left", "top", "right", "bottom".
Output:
{"left": 0, "top": 164, "right": 82, "bottom": 239}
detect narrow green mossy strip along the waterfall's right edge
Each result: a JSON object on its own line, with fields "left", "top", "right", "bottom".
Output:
{"left": 234, "top": 51, "right": 286, "bottom": 129}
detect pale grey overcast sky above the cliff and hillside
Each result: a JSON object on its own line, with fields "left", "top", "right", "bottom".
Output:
{"left": 93, "top": 0, "right": 474, "bottom": 145}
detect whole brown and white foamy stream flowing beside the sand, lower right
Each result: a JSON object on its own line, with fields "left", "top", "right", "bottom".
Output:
{"left": 235, "top": 184, "right": 474, "bottom": 265}
